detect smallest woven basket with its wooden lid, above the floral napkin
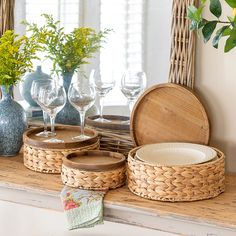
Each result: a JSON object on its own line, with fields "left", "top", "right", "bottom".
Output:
{"left": 61, "top": 151, "right": 126, "bottom": 190}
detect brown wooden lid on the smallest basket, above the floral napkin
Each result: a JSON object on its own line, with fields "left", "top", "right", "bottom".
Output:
{"left": 63, "top": 151, "right": 125, "bottom": 171}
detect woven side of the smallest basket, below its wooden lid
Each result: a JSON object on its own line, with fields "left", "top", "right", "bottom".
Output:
{"left": 61, "top": 164, "right": 126, "bottom": 190}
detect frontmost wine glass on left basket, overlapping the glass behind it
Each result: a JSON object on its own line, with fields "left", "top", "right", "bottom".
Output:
{"left": 38, "top": 81, "right": 66, "bottom": 143}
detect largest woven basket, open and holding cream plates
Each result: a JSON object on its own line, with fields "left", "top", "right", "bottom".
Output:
{"left": 128, "top": 148, "right": 225, "bottom": 202}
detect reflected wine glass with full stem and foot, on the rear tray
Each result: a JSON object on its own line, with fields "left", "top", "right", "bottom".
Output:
{"left": 92, "top": 70, "right": 115, "bottom": 122}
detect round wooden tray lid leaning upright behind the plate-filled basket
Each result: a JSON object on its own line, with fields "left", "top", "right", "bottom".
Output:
{"left": 130, "top": 83, "right": 210, "bottom": 146}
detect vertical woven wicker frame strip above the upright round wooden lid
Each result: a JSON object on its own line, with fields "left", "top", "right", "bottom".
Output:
{"left": 169, "top": 0, "right": 198, "bottom": 88}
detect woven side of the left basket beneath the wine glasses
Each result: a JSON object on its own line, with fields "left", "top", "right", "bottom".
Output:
{"left": 24, "top": 140, "right": 99, "bottom": 174}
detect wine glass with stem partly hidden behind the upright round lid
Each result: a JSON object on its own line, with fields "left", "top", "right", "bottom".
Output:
{"left": 121, "top": 71, "right": 146, "bottom": 115}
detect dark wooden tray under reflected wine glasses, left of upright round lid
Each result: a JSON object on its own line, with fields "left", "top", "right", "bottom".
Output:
{"left": 86, "top": 115, "right": 130, "bottom": 131}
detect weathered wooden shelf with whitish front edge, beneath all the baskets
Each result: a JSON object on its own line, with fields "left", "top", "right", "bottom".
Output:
{"left": 0, "top": 154, "right": 236, "bottom": 236}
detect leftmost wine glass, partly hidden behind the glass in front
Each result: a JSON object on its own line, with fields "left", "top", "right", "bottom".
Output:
{"left": 30, "top": 79, "right": 53, "bottom": 138}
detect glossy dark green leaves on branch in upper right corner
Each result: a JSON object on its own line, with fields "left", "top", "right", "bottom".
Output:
{"left": 188, "top": 0, "right": 236, "bottom": 52}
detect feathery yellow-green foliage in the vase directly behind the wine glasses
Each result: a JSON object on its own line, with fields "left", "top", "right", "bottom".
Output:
{"left": 24, "top": 14, "right": 110, "bottom": 74}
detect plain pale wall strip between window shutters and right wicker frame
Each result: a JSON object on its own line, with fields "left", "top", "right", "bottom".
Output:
{"left": 145, "top": 0, "right": 172, "bottom": 86}
